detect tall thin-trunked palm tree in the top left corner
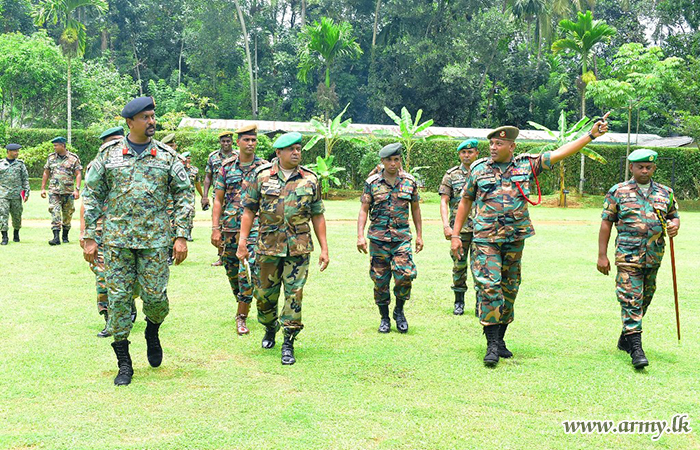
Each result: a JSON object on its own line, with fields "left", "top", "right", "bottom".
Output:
{"left": 32, "top": 0, "right": 108, "bottom": 144}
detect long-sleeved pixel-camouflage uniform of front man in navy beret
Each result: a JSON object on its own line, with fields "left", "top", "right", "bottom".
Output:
{"left": 84, "top": 138, "right": 194, "bottom": 341}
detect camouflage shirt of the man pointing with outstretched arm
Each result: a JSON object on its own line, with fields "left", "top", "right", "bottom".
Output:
{"left": 462, "top": 152, "right": 552, "bottom": 243}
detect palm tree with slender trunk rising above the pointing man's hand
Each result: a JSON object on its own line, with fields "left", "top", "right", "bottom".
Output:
{"left": 552, "top": 11, "right": 616, "bottom": 195}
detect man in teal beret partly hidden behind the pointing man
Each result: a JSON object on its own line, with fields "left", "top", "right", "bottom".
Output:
{"left": 438, "top": 139, "right": 479, "bottom": 316}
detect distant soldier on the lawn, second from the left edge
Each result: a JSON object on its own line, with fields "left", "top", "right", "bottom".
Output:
{"left": 41, "top": 136, "right": 83, "bottom": 245}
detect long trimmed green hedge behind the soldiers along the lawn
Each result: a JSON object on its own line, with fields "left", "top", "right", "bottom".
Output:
{"left": 7, "top": 125, "right": 700, "bottom": 199}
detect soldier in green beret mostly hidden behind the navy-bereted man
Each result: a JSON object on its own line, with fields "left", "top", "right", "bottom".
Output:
{"left": 80, "top": 127, "right": 138, "bottom": 338}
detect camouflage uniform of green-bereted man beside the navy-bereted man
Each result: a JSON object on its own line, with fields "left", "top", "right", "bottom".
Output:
{"left": 243, "top": 162, "right": 324, "bottom": 337}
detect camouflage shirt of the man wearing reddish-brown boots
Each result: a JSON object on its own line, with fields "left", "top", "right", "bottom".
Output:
{"left": 215, "top": 156, "right": 268, "bottom": 235}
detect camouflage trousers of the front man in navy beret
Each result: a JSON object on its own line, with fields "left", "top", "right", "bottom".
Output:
{"left": 104, "top": 246, "right": 170, "bottom": 341}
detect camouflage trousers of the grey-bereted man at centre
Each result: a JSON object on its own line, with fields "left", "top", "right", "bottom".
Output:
{"left": 369, "top": 239, "right": 418, "bottom": 305}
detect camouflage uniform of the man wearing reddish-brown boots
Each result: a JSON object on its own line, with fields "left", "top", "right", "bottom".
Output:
{"left": 214, "top": 156, "right": 267, "bottom": 303}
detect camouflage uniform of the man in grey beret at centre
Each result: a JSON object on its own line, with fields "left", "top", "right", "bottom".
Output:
{"left": 360, "top": 171, "right": 420, "bottom": 306}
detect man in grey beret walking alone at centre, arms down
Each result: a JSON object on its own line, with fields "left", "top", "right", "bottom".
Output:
{"left": 357, "top": 143, "right": 423, "bottom": 333}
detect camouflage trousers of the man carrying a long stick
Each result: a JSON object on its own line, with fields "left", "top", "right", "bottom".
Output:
{"left": 615, "top": 266, "right": 659, "bottom": 334}
